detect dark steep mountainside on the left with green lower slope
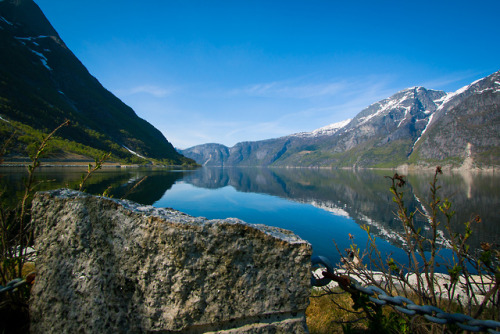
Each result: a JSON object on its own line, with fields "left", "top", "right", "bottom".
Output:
{"left": 0, "top": 0, "right": 192, "bottom": 164}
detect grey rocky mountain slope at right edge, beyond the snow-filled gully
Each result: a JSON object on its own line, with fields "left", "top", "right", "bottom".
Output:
{"left": 410, "top": 71, "right": 500, "bottom": 168}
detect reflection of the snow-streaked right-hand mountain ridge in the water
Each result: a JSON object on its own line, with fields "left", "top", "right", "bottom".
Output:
{"left": 178, "top": 168, "right": 500, "bottom": 246}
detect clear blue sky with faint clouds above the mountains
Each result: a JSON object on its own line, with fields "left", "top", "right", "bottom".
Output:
{"left": 35, "top": 0, "right": 500, "bottom": 148}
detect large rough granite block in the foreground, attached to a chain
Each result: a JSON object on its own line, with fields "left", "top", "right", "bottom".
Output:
{"left": 30, "top": 189, "right": 311, "bottom": 333}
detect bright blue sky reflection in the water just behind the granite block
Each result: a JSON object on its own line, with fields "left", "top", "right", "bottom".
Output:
{"left": 153, "top": 182, "right": 405, "bottom": 263}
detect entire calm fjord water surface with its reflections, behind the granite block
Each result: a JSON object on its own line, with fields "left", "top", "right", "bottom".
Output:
{"left": 0, "top": 167, "right": 500, "bottom": 263}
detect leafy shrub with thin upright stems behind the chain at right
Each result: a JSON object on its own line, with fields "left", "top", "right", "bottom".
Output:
{"left": 320, "top": 167, "right": 500, "bottom": 332}
